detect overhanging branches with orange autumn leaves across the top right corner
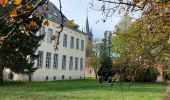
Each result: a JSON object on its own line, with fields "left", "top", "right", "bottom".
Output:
{"left": 93, "top": 0, "right": 170, "bottom": 17}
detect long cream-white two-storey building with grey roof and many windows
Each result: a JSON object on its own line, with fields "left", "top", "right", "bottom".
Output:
{"left": 4, "top": 3, "right": 87, "bottom": 81}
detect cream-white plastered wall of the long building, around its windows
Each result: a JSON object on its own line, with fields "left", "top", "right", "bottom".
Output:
{"left": 4, "top": 21, "right": 86, "bottom": 81}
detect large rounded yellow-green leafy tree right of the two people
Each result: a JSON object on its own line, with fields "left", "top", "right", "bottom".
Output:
{"left": 112, "top": 12, "right": 169, "bottom": 81}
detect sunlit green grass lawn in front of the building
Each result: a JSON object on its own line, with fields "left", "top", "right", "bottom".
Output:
{"left": 0, "top": 79, "right": 166, "bottom": 100}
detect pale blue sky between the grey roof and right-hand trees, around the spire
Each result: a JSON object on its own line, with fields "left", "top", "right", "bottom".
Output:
{"left": 50, "top": 0, "right": 122, "bottom": 38}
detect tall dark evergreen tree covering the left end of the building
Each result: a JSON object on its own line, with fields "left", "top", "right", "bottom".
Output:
{"left": 0, "top": 0, "right": 46, "bottom": 85}
